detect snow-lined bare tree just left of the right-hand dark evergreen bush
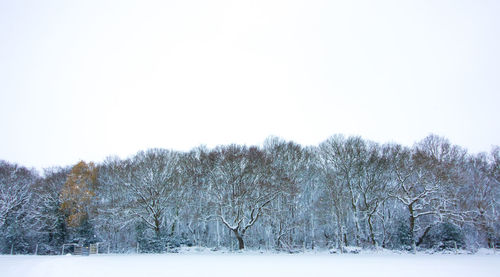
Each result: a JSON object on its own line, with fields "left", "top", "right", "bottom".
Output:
{"left": 391, "top": 136, "right": 464, "bottom": 251}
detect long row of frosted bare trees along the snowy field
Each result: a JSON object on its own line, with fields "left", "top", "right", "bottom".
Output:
{"left": 0, "top": 135, "right": 500, "bottom": 254}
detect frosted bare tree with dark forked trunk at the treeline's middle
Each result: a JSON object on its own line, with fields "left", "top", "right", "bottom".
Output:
{"left": 209, "top": 145, "right": 278, "bottom": 249}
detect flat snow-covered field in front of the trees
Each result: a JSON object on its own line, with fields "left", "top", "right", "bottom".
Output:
{"left": 0, "top": 248, "right": 500, "bottom": 277}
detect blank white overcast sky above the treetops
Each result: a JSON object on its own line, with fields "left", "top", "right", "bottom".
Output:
{"left": 0, "top": 0, "right": 500, "bottom": 169}
